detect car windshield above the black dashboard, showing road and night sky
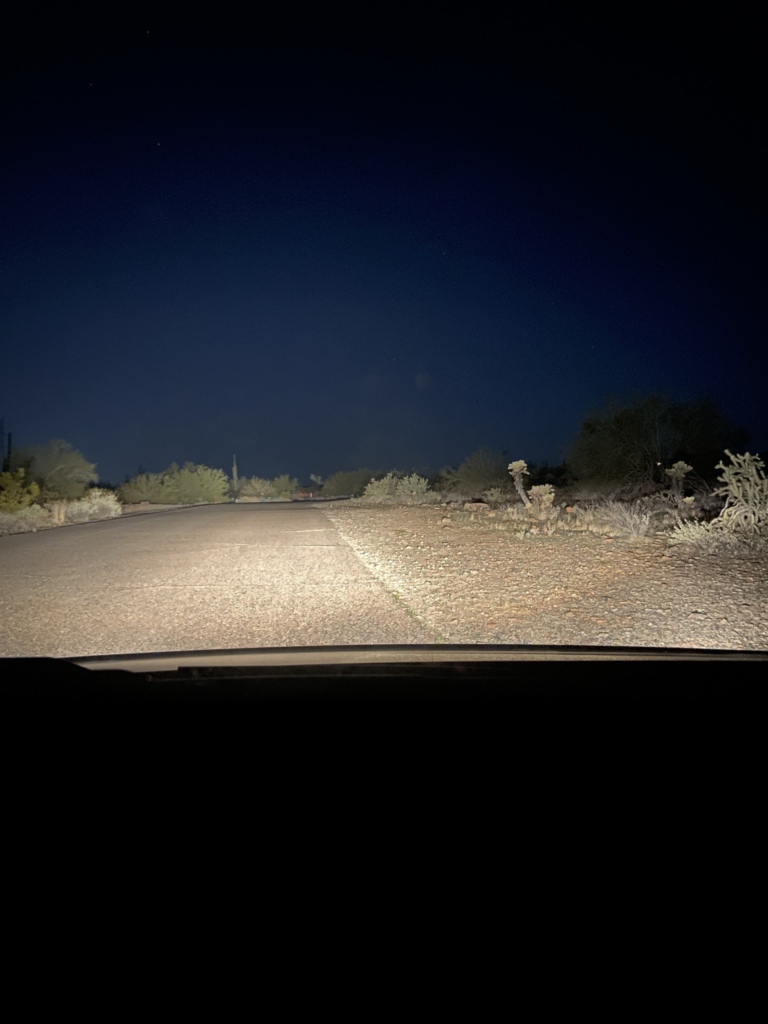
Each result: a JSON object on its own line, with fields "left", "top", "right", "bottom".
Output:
{"left": 0, "top": 5, "right": 768, "bottom": 658}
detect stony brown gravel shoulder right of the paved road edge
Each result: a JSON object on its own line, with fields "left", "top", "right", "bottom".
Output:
{"left": 322, "top": 504, "right": 768, "bottom": 650}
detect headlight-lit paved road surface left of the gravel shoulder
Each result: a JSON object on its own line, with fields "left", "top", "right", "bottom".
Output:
{"left": 0, "top": 504, "right": 436, "bottom": 657}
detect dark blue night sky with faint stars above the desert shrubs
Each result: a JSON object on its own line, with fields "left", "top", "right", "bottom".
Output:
{"left": 0, "top": 3, "right": 768, "bottom": 483}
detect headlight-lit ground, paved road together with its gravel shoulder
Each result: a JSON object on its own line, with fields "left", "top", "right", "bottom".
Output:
{"left": 0, "top": 502, "right": 768, "bottom": 657}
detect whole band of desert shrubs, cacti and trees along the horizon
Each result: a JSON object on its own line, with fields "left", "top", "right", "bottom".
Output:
{"left": 0, "top": 395, "right": 768, "bottom": 553}
